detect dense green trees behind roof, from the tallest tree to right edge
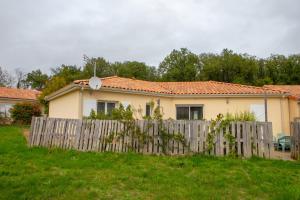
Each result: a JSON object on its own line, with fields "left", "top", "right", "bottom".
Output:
{"left": 159, "top": 49, "right": 300, "bottom": 86}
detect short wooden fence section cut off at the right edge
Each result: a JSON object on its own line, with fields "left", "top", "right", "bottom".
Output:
{"left": 291, "top": 118, "right": 300, "bottom": 159}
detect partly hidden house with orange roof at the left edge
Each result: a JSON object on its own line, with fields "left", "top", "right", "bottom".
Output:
{"left": 0, "top": 87, "right": 40, "bottom": 117}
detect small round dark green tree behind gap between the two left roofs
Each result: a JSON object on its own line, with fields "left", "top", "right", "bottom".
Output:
{"left": 25, "top": 69, "right": 49, "bottom": 90}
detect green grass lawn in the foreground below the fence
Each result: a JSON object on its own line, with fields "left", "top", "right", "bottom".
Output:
{"left": 0, "top": 127, "right": 300, "bottom": 199}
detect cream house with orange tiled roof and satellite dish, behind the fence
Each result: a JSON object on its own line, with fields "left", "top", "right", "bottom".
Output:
{"left": 46, "top": 76, "right": 299, "bottom": 136}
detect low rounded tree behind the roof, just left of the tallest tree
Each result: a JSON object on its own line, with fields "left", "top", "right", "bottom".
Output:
{"left": 112, "top": 61, "right": 158, "bottom": 81}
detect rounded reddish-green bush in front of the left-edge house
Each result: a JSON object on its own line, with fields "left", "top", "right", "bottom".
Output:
{"left": 9, "top": 102, "right": 41, "bottom": 124}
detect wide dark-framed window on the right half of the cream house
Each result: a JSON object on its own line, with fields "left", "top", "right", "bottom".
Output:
{"left": 176, "top": 105, "right": 203, "bottom": 120}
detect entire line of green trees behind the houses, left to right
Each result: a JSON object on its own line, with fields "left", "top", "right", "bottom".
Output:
{"left": 17, "top": 48, "right": 300, "bottom": 111}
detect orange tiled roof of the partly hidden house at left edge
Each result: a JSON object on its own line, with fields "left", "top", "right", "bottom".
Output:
{"left": 0, "top": 87, "right": 41, "bottom": 100}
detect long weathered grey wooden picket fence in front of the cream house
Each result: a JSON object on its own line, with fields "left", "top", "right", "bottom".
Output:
{"left": 29, "top": 117, "right": 273, "bottom": 158}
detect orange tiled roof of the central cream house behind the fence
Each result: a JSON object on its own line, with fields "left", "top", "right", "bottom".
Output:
{"left": 74, "top": 76, "right": 284, "bottom": 95}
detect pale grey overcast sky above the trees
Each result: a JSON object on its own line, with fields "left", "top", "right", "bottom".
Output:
{"left": 0, "top": 0, "right": 300, "bottom": 72}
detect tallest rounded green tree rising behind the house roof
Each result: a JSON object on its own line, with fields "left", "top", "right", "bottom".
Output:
{"left": 159, "top": 48, "right": 201, "bottom": 81}
